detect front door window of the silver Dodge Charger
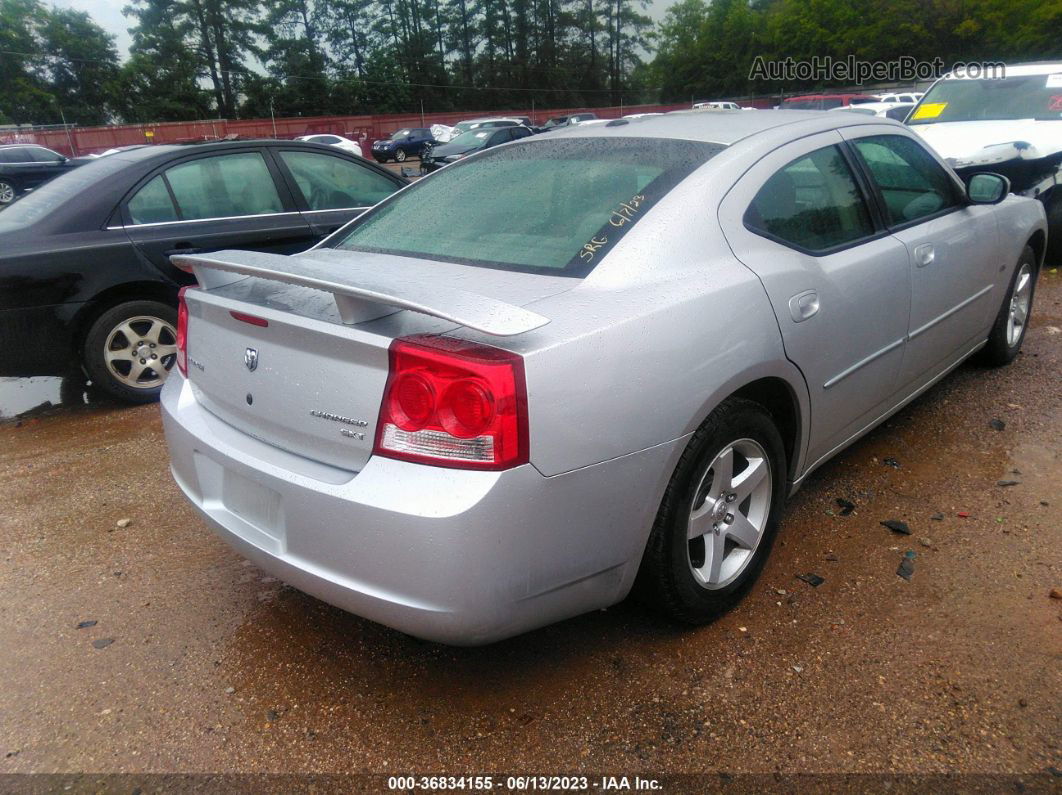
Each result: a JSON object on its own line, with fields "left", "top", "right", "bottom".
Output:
{"left": 853, "top": 135, "right": 958, "bottom": 226}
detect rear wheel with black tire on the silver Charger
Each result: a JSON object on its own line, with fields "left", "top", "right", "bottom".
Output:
{"left": 638, "top": 398, "right": 786, "bottom": 624}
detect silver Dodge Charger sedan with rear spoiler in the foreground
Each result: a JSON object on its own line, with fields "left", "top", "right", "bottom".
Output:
{"left": 162, "top": 110, "right": 1046, "bottom": 644}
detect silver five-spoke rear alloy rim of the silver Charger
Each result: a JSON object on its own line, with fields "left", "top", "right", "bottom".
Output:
{"left": 686, "top": 438, "right": 772, "bottom": 590}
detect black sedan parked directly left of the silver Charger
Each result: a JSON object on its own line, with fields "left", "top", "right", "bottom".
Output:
{"left": 0, "top": 141, "right": 406, "bottom": 402}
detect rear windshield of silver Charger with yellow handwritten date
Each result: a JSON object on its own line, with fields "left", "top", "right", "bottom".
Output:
{"left": 335, "top": 138, "right": 724, "bottom": 276}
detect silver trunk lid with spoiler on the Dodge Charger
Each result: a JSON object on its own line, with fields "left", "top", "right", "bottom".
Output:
{"left": 179, "top": 249, "right": 579, "bottom": 471}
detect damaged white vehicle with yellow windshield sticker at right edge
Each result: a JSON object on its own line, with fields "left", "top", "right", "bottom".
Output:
{"left": 907, "top": 61, "right": 1062, "bottom": 259}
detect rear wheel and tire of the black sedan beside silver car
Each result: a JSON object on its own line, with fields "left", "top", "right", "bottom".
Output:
{"left": 82, "top": 300, "right": 177, "bottom": 403}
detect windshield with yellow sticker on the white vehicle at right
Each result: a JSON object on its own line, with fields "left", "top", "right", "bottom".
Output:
{"left": 907, "top": 72, "right": 1062, "bottom": 124}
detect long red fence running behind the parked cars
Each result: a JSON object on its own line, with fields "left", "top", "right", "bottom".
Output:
{"left": 0, "top": 99, "right": 769, "bottom": 156}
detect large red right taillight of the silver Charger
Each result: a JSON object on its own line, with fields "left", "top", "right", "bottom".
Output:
{"left": 373, "top": 336, "right": 528, "bottom": 469}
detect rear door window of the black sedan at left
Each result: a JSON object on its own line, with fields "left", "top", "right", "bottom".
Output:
{"left": 166, "top": 152, "right": 284, "bottom": 221}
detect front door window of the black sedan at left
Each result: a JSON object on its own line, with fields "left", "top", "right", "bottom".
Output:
{"left": 280, "top": 152, "right": 397, "bottom": 210}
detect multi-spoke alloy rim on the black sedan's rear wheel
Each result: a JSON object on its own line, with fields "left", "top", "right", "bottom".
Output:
{"left": 103, "top": 315, "right": 177, "bottom": 390}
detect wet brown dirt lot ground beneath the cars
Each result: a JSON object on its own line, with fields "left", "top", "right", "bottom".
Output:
{"left": 0, "top": 273, "right": 1062, "bottom": 776}
